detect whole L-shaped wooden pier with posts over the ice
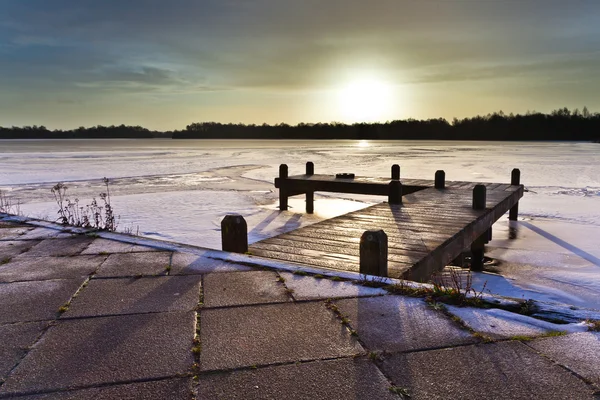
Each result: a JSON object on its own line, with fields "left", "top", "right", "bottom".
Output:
{"left": 223, "top": 163, "right": 524, "bottom": 281}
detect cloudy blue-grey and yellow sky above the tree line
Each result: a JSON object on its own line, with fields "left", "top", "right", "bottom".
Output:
{"left": 0, "top": 0, "right": 600, "bottom": 130}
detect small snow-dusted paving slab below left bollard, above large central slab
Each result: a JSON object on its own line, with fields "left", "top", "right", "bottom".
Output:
{"left": 204, "top": 271, "right": 291, "bottom": 307}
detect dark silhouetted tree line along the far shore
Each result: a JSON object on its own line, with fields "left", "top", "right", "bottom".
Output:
{"left": 0, "top": 107, "right": 600, "bottom": 141}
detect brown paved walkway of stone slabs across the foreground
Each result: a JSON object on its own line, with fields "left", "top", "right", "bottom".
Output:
{"left": 0, "top": 216, "right": 600, "bottom": 400}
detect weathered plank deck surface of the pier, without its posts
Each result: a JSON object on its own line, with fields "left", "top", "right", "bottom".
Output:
{"left": 250, "top": 185, "right": 523, "bottom": 281}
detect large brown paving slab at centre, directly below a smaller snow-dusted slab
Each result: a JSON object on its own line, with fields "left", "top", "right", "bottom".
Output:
{"left": 200, "top": 302, "right": 363, "bottom": 370}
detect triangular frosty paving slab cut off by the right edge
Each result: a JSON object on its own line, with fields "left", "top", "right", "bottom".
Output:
{"left": 527, "top": 332, "right": 600, "bottom": 387}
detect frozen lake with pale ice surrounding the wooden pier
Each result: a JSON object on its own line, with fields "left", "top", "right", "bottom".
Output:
{"left": 0, "top": 139, "right": 600, "bottom": 309}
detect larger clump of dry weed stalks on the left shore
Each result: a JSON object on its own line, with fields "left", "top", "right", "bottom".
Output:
{"left": 50, "top": 178, "right": 118, "bottom": 232}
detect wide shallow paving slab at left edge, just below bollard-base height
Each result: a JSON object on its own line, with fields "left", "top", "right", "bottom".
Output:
{"left": 0, "top": 255, "right": 106, "bottom": 282}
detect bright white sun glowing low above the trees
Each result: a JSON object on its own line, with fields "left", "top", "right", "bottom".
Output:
{"left": 338, "top": 79, "right": 393, "bottom": 122}
